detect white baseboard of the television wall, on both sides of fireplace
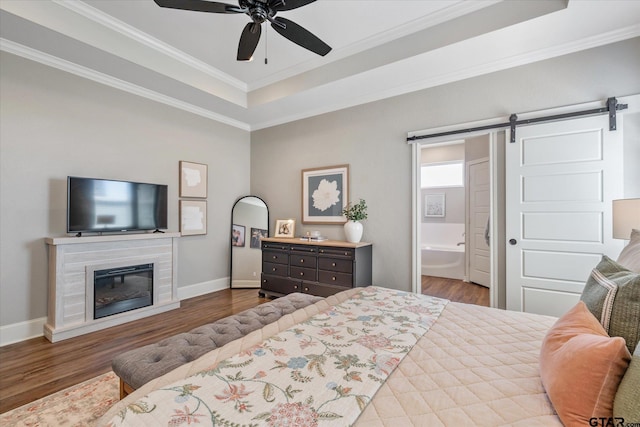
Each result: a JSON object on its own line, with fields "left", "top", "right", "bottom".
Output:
{"left": 0, "top": 277, "right": 229, "bottom": 347}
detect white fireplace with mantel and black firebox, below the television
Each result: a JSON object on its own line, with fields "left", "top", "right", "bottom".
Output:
{"left": 44, "top": 232, "right": 180, "bottom": 342}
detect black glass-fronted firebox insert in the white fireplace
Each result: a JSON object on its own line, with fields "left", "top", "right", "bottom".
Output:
{"left": 93, "top": 263, "right": 153, "bottom": 319}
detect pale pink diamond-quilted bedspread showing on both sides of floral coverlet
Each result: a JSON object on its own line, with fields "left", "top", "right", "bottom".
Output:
{"left": 100, "top": 289, "right": 562, "bottom": 427}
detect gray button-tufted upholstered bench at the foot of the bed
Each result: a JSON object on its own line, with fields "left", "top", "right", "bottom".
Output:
{"left": 111, "top": 293, "right": 322, "bottom": 399}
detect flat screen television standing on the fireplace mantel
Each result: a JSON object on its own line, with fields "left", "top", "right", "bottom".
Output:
{"left": 67, "top": 176, "right": 167, "bottom": 237}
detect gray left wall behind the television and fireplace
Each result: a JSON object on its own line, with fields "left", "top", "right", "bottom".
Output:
{"left": 0, "top": 53, "right": 250, "bottom": 326}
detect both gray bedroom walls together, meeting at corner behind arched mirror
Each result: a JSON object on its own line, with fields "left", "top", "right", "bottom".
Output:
{"left": 0, "top": 38, "right": 640, "bottom": 332}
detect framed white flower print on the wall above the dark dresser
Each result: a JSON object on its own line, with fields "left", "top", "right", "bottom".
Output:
{"left": 302, "top": 165, "right": 349, "bottom": 224}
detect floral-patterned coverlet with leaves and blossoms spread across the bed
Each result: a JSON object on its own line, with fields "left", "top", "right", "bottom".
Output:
{"left": 107, "top": 287, "right": 448, "bottom": 427}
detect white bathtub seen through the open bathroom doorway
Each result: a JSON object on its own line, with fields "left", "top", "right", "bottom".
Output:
{"left": 421, "top": 245, "right": 465, "bottom": 280}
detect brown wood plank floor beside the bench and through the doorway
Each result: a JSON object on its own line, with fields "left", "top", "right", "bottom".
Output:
{"left": 0, "top": 276, "right": 489, "bottom": 413}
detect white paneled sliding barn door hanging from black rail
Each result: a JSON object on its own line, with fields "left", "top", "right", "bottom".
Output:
{"left": 505, "top": 115, "right": 623, "bottom": 316}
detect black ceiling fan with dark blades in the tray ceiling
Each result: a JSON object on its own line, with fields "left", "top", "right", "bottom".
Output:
{"left": 154, "top": 0, "right": 331, "bottom": 61}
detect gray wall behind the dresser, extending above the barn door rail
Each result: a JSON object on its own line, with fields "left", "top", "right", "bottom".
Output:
{"left": 251, "top": 38, "right": 640, "bottom": 290}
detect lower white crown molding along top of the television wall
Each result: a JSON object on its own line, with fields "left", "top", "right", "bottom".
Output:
{"left": 0, "top": 38, "right": 251, "bottom": 131}
